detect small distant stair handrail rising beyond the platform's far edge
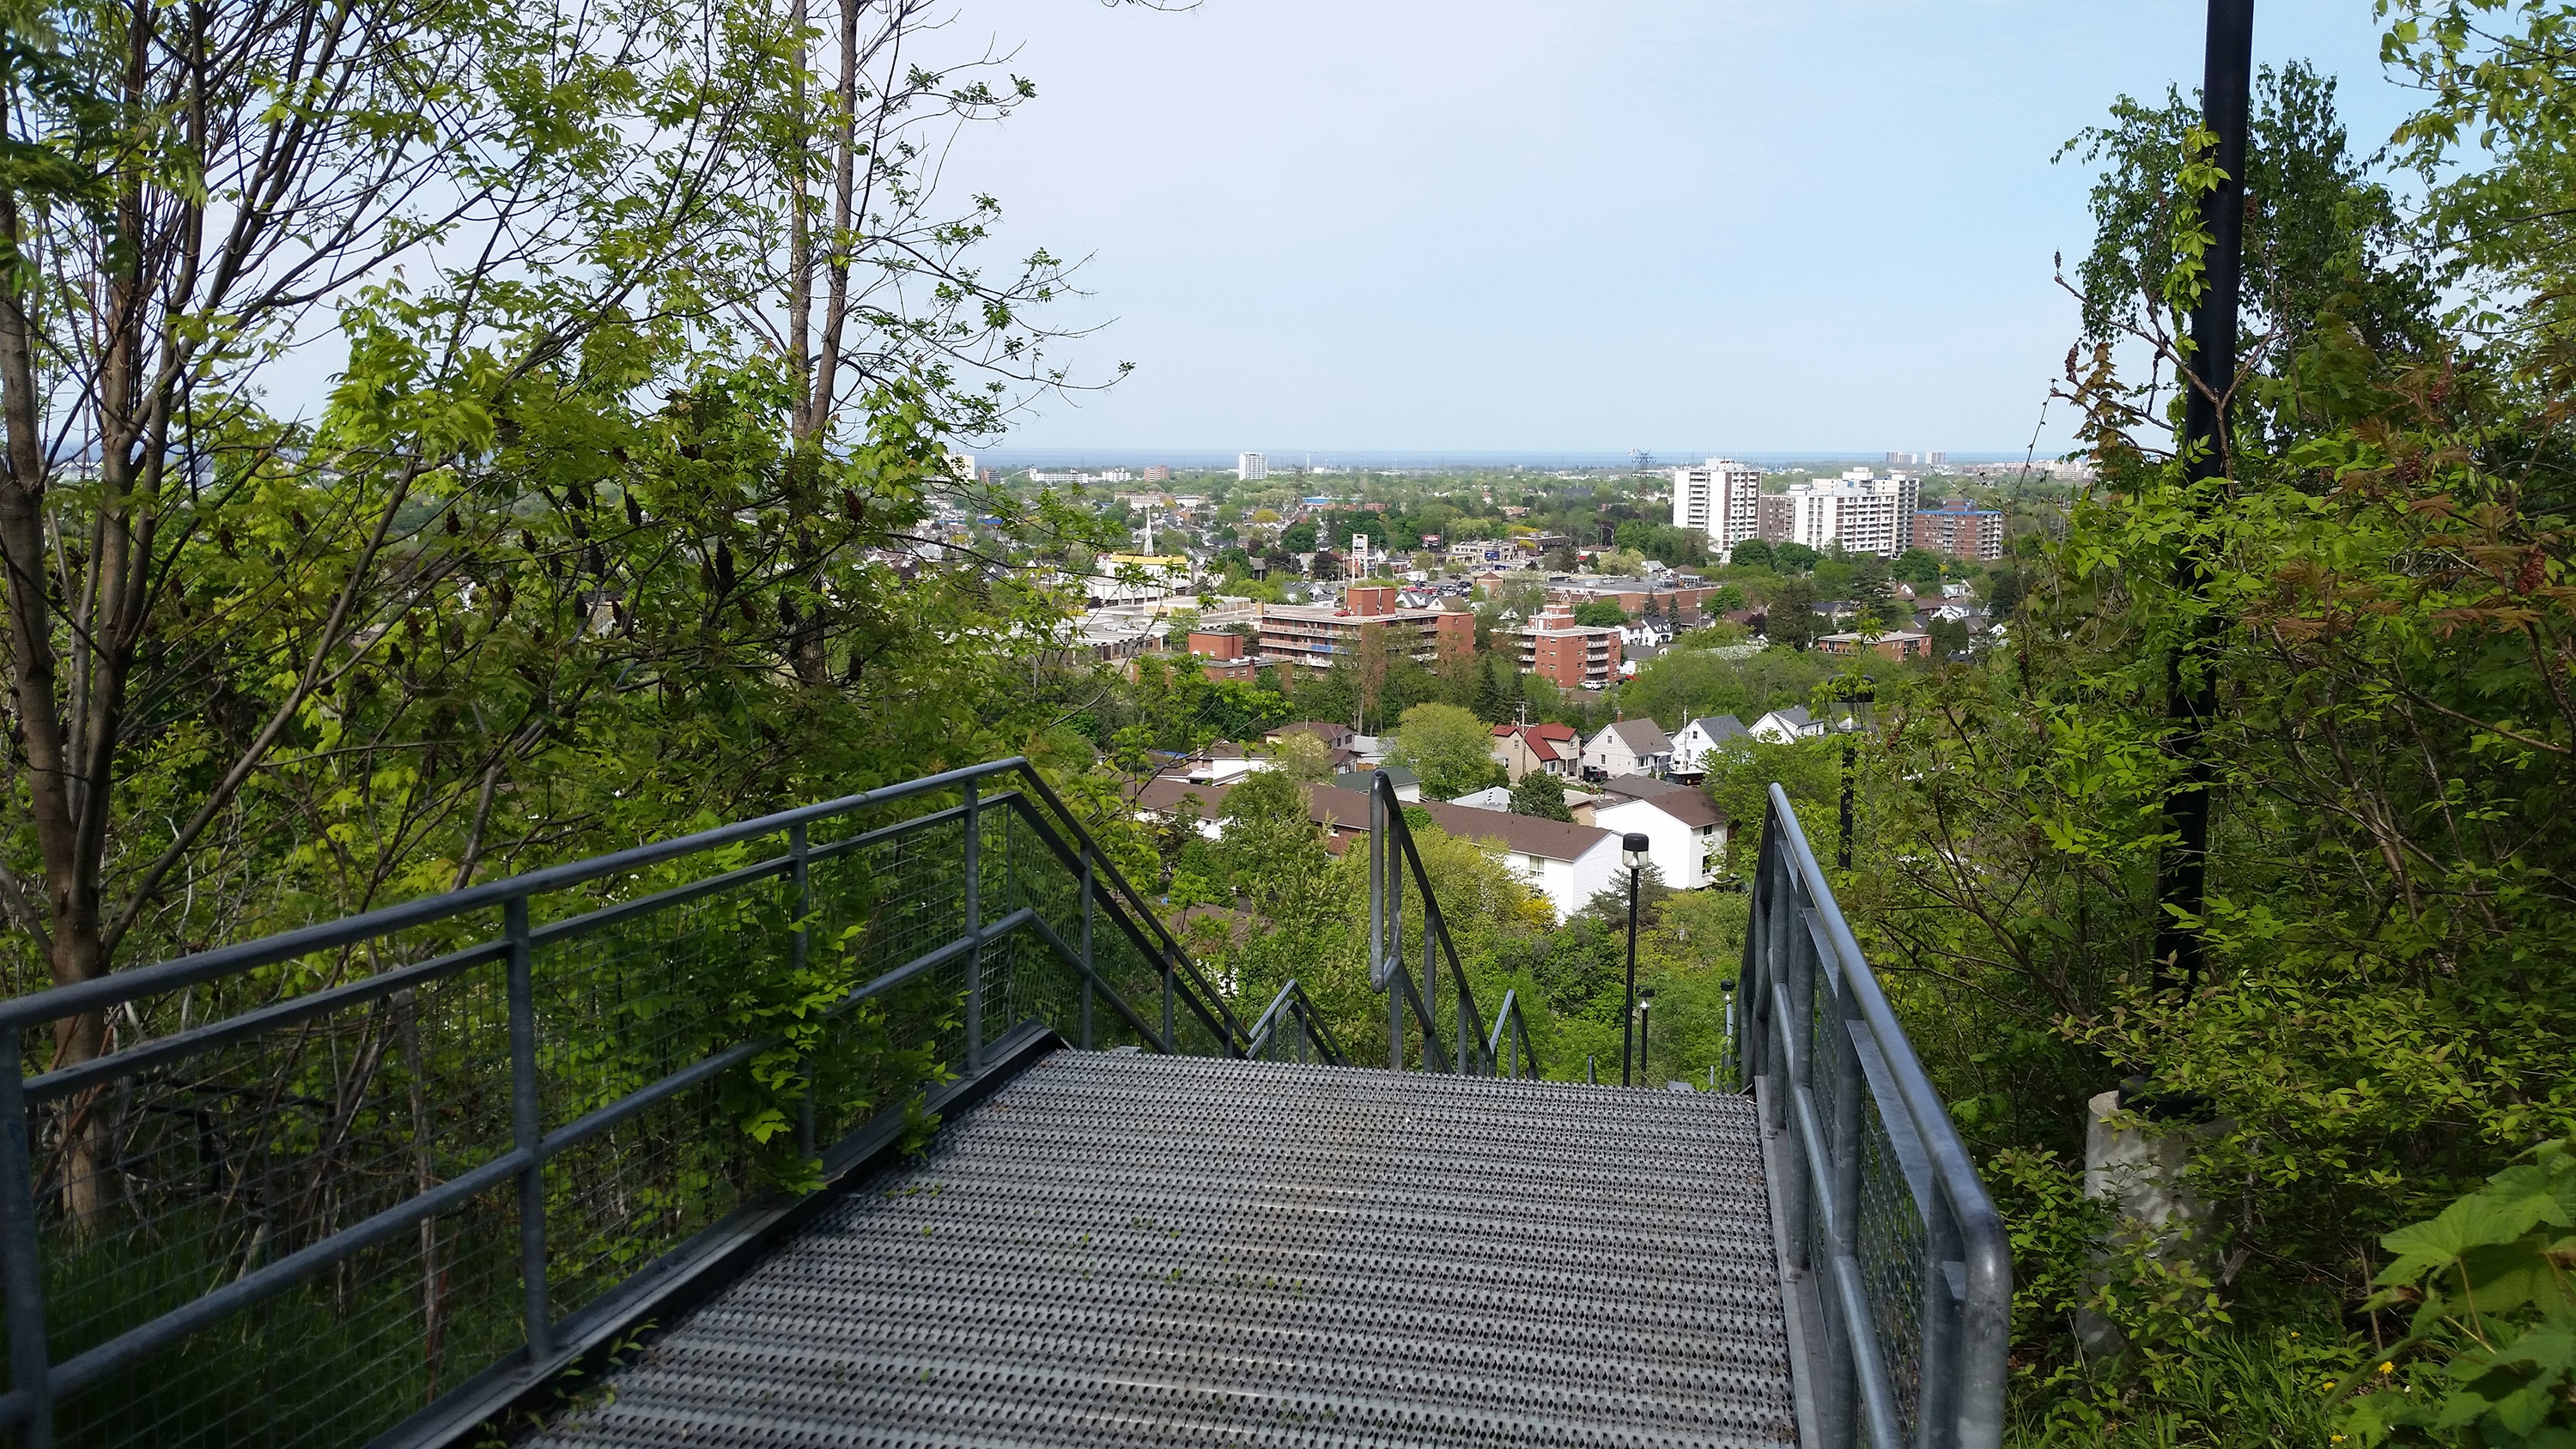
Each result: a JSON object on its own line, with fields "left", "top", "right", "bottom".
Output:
{"left": 1368, "top": 769, "right": 1538, "bottom": 1078}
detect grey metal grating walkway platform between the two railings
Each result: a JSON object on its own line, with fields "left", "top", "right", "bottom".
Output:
{"left": 531, "top": 1052, "right": 1795, "bottom": 1449}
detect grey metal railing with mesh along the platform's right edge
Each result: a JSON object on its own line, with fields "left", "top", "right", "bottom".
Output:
{"left": 1741, "top": 785, "right": 2012, "bottom": 1449}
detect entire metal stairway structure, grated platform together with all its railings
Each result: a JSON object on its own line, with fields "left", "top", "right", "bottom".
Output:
{"left": 0, "top": 759, "right": 2009, "bottom": 1449}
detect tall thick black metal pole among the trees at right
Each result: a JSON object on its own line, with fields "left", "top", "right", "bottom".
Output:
{"left": 2156, "top": 0, "right": 2254, "bottom": 991}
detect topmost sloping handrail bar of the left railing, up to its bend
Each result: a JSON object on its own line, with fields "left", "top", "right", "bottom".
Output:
{"left": 0, "top": 754, "right": 1036, "bottom": 1029}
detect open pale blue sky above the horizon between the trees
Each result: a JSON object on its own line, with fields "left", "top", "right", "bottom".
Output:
{"left": 948, "top": 0, "right": 2406, "bottom": 461}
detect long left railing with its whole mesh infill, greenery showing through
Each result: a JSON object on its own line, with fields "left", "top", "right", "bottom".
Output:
{"left": 0, "top": 759, "right": 1236, "bottom": 1449}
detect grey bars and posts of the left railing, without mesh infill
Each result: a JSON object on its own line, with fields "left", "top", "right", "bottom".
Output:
{"left": 0, "top": 756, "right": 1236, "bottom": 1449}
